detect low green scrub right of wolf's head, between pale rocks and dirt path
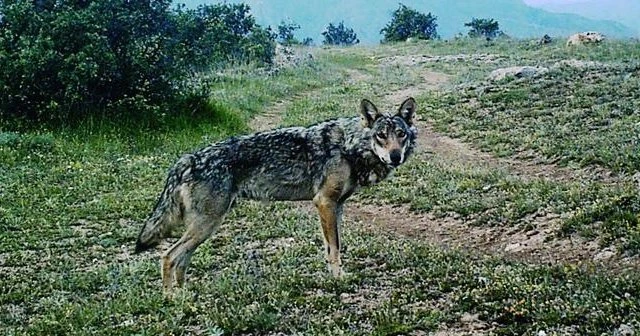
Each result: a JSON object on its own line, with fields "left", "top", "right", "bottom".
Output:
{"left": 433, "top": 66, "right": 640, "bottom": 172}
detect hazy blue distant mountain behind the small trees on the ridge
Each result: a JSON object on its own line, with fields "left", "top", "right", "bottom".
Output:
{"left": 176, "top": 0, "right": 636, "bottom": 44}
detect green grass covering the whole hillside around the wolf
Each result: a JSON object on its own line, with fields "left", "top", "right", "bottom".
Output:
{"left": 0, "top": 40, "right": 640, "bottom": 335}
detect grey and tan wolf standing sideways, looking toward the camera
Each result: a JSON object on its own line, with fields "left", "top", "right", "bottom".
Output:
{"left": 135, "top": 97, "right": 417, "bottom": 292}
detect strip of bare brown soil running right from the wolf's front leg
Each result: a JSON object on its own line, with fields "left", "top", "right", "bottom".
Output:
{"left": 344, "top": 203, "right": 637, "bottom": 267}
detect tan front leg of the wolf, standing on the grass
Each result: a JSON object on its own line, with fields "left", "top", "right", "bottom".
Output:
{"left": 313, "top": 194, "right": 343, "bottom": 277}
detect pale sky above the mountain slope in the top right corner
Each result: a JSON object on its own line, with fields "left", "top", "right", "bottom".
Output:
{"left": 525, "top": 0, "right": 640, "bottom": 36}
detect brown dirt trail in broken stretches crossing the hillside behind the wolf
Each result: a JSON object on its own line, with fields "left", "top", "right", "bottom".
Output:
{"left": 255, "top": 57, "right": 638, "bottom": 268}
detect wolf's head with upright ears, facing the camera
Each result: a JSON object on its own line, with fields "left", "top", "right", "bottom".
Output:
{"left": 360, "top": 98, "right": 418, "bottom": 167}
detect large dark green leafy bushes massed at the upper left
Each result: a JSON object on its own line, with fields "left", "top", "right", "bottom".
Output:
{"left": 0, "top": 0, "right": 274, "bottom": 126}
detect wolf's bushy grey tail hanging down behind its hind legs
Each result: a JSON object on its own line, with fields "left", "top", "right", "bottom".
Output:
{"left": 135, "top": 155, "right": 193, "bottom": 253}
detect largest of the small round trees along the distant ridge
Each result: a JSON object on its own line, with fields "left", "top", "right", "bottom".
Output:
{"left": 380, "top": 4, "right": 439, "bottom": 42}
